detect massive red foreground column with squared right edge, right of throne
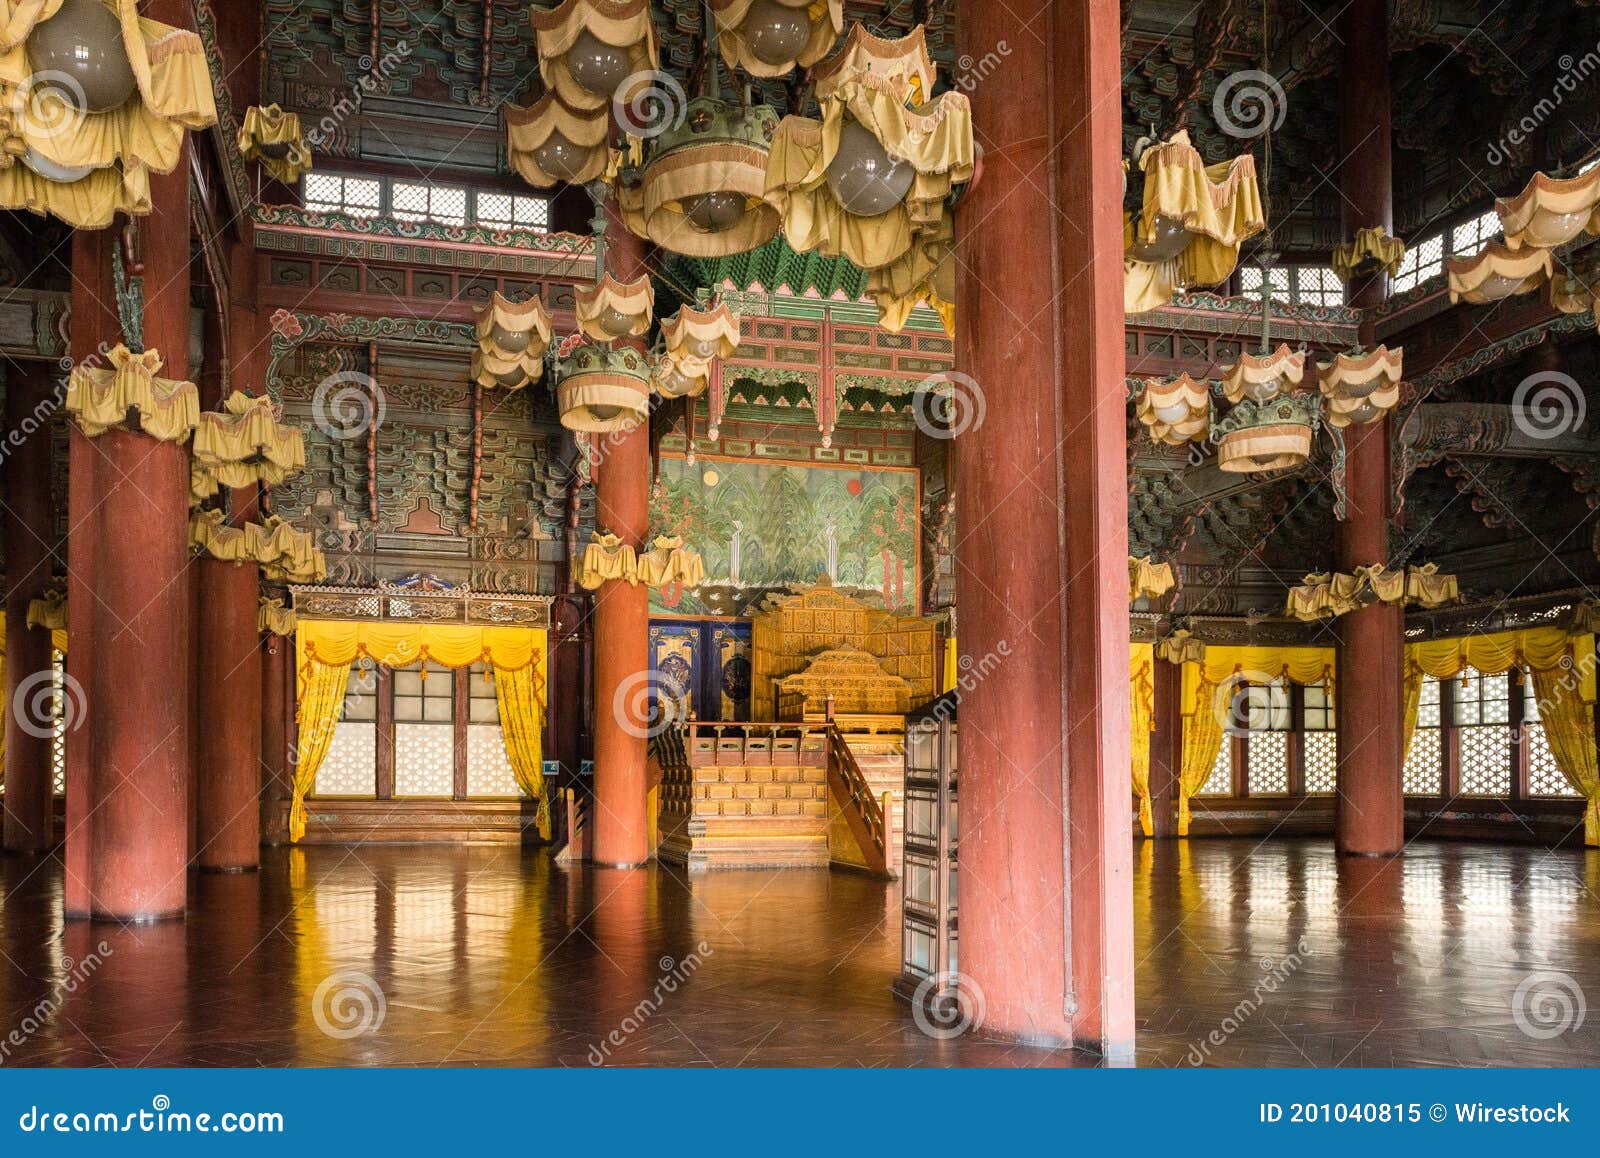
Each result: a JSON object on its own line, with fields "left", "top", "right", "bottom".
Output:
{"left": 955, "top": 0, "right": 1133, "bottom": 1057}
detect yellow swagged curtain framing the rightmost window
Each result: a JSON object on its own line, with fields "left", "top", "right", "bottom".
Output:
{"left": 1405, "top": 627, "right": 1600, "bottom": 846}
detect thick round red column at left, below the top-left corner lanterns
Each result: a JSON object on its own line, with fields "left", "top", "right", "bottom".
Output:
{"left": 88, "top": 97, "right": 194, "bottom": 921}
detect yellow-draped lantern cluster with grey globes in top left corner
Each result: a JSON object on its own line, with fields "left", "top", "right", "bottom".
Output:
{"left": 0, "top": 0, "right": 216, "bottom": 229}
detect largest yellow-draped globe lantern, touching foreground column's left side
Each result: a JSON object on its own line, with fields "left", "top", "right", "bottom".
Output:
{"left": 766, "top": 24, "right": 974, "bottom": 270}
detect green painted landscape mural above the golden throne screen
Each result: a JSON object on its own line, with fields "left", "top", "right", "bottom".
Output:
{"left": 651, "top": 457, "right": 918, "bottom": 616}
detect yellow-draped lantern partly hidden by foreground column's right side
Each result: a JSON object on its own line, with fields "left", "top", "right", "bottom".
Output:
{"left": 1123, "top": 130, "right": 1267, "bottom": 313}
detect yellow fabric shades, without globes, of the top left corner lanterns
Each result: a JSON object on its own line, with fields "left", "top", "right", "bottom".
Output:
{"left": 0, "top": 0, "right": 216, "bottom": 229}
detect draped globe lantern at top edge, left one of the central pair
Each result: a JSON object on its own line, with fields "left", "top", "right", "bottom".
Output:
{"left": 533, "top": 0, "right": 661, "bottom": 109}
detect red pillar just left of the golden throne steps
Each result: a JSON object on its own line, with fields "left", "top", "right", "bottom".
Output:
{"left": 594, "top": 205, "right": 651, "bottom": 867}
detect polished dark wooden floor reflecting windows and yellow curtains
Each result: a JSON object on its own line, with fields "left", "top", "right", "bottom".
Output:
{"left": 0, "top": 840, "right": 1600, "bottom": 1065}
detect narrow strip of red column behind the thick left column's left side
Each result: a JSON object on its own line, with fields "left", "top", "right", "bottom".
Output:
{"left": 64, "top": 229, "right": 120, "bottom": 918}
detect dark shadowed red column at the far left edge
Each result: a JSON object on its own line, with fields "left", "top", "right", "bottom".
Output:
{"left": 0, "top": 361, "right": 60, "bottom": 853}
